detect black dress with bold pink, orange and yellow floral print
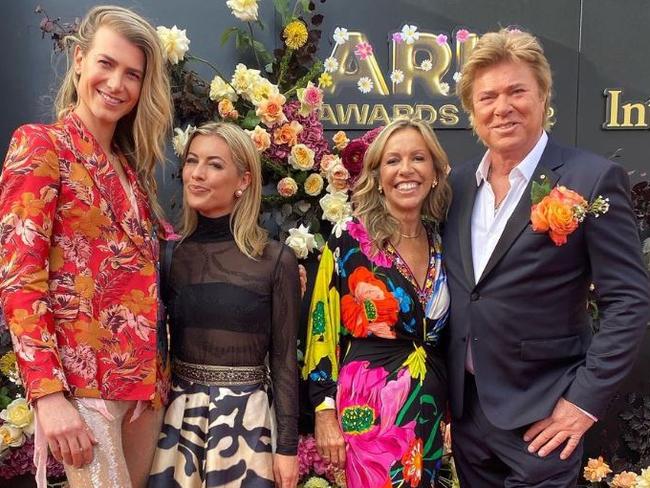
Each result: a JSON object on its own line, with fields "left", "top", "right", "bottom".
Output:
{"left": 303, "top": 220, "right": 449, "bottom": 488}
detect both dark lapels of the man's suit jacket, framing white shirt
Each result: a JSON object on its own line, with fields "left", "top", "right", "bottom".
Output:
{"left": 459, "top": 138, "right": 564, "bottom": 287}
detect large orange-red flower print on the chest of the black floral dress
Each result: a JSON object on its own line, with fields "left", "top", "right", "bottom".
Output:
{"left": 341, "top": 266, "right": 399, "bottom": 339}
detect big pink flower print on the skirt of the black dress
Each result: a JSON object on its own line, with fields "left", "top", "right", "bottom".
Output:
{"left": 336, "top": 361, "right": 415, "bottom": 487}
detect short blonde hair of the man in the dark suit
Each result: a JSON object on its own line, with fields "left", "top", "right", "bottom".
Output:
{"left": 456, "top": 29, "right": 553, "bottom": 129}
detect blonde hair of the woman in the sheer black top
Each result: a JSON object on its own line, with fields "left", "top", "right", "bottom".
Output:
{"left": 181, "top": 122, "right": 268, "bottom": 259}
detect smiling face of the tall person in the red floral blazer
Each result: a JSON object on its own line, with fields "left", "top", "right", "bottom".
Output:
{"left": 74, "top": 26, "right": 146, "bottom": 135}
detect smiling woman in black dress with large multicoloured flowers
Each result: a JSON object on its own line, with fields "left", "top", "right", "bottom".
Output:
{"left": 303, "top": 119, "right": 450, "bottom": 488}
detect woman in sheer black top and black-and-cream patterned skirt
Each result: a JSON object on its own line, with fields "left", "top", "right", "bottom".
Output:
{"left": 149, "top": 123, "right": 300, "bottom": 488}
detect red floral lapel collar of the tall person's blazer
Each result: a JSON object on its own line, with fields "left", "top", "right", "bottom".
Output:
{"left": 63, "top": 113, "right": 156, "bottom": 259}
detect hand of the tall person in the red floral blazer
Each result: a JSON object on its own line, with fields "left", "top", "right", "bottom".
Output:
{"left": 36, "top": 392, "right": 97, "bottom": 468}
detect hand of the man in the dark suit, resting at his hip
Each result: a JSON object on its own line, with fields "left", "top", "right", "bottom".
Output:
{"left": 524, "top": 398, "right": 594, "bottom": 460}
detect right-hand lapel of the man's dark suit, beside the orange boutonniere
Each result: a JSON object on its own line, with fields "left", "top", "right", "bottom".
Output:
{"left": 477, "top": 138, "right": 563, "bottom": 284}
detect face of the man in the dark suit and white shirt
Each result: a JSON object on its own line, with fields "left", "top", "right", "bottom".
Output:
{"left": 472, "top": 61, "right": 546, "bottom": 163}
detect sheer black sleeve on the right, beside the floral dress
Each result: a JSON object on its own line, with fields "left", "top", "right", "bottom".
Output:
{"left": 269, "top": 246, "right": 300, "bottom": 455}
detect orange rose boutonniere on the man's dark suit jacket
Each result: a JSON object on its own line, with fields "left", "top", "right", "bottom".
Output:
{"left": 530, "top": 175, "right": 609, "bottom": 246}
